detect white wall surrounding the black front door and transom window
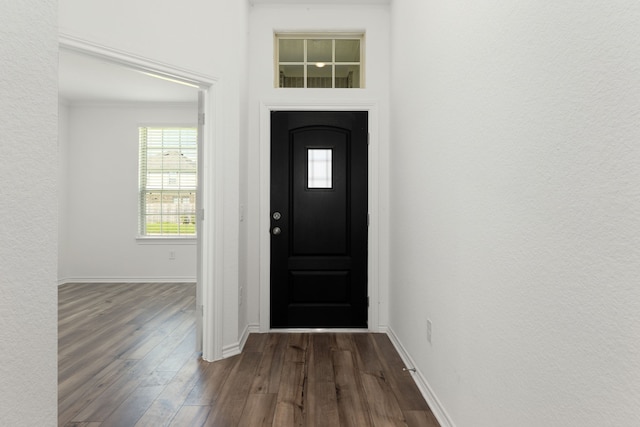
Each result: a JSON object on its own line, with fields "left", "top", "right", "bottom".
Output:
{"left": 248, "top": 4, "right": 389, "bottom": 328}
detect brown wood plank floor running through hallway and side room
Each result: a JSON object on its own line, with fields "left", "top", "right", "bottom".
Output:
{"left": 58, "top": 283, "right": 438, "bottom": 427}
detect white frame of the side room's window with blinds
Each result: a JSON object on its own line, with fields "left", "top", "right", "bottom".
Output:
{"left": 136, "top": 123, "right": 200, "bottom": 244}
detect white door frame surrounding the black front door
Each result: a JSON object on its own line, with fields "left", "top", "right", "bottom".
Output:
{"left": 259, "top": 101, "right": 380, "bottom": 332}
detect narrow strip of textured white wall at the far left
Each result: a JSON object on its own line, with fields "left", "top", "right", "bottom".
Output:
{"left": 0, "top": 0, "right": 58, "bottom": 426}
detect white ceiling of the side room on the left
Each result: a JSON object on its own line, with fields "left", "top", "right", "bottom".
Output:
{"left": 58, "top": 49, "right": 198, "bottom": 103}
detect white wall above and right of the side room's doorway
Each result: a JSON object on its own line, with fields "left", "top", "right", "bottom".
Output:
{"left": 59, "top": 0, "right": 248, "bottom": 354}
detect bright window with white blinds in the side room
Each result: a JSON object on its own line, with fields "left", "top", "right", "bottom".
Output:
{"left": 139, "top": 127, "right": 198, "bottom": 237}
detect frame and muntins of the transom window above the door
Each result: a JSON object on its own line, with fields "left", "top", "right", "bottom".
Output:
{"left": 273, "top": 31, "right": 366, "bottom": 90}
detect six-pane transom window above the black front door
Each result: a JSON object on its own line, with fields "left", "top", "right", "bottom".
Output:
{"left": 275, "top": 33, "right": 364, "bottom": 89}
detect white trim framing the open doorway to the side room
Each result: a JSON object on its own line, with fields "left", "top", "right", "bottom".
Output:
{"left": 59, "top": 34, "right": 224, "bottom": 361}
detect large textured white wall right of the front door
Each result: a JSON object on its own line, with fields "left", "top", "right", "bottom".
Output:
{"left": 390, "top": 0, "right": 640, "bottom": 427}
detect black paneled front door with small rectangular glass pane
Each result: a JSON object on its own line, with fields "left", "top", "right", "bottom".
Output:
{"left": 270, "top": 111, "right": 368, "bottom": 328}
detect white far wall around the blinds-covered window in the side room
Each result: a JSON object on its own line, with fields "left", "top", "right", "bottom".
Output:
{"left": 59, "top": 103, "right": 198, "bottom": 282}
